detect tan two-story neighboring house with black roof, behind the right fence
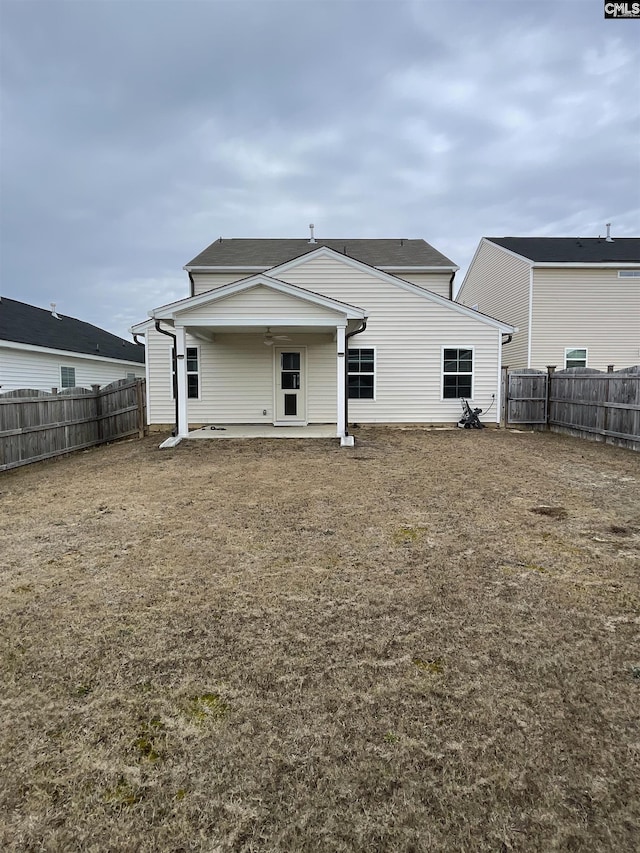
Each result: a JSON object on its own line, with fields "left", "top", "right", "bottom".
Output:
{"left": 456, "top": 235, "right": 640, "bottom": 370}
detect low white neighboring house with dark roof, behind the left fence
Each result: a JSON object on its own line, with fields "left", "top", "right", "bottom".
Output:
{"left": 0, "top": 297, "right": 145, "bottom": 394}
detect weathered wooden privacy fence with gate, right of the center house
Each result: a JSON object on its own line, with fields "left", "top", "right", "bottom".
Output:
{"left": 505, "top": 365, "right": 640, "bottom": 450}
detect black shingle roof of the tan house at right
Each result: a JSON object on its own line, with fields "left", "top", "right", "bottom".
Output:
{"left": 486, "top": 237, "right": 640, "bottom": 264}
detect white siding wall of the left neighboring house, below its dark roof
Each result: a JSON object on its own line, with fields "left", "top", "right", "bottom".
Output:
{"left": 0, "top": 341, "right": 145, "bottom": 394}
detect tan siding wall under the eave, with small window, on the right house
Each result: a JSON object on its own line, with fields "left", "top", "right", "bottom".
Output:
{"left": 531, "top": 268, "right": 640, "bottom": 370}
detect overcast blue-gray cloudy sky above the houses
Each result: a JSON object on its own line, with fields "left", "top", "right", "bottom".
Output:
{"left": 0, "top": 0, "right": 640, "bottom": 337}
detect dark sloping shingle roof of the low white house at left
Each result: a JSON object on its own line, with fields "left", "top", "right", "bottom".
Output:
{"left": 0, "top": 297, "right": 145, "bottom": 364}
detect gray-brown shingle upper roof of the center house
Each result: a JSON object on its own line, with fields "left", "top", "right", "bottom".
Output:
{"left": 186, "top": 237, "right": 456, "bottom": 269}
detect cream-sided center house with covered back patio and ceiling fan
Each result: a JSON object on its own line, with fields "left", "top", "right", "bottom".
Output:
{"left": 131, "top": 235, "right": 514, "bottom": 444}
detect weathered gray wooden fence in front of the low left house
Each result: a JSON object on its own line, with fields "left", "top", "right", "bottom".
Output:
{"left": 0, "top": 379, "right": 146, "bottom": 471}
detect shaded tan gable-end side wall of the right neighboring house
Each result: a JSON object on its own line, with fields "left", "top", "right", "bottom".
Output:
{"left": 456, "top": 241, "right": 530, "bottom": 367}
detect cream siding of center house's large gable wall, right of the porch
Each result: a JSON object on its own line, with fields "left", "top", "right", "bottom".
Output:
{"left": 277, "top": 258, "right": 501, "bottom": 423}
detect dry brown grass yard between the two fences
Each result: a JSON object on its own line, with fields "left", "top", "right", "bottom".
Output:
{"left": 0, "top": 429, "right": 640, "bottom": 853}
